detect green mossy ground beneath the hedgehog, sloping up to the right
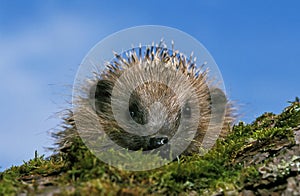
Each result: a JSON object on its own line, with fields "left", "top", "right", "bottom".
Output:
{"left": 0, "top": 97, "right": 300, "bottom": 195}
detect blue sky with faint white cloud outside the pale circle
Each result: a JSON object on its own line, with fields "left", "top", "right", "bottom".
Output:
{"left": 0, "top": 0, "right": 300, "bottom": 170}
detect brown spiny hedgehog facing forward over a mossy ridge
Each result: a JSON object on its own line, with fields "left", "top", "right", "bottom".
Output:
{"left": 55, "top": 42, "right": 234, "bottom": 161}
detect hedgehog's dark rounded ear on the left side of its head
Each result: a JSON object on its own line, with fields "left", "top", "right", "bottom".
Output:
{"left": 90, "top": 80, "right": 113, "bottom": 113}
